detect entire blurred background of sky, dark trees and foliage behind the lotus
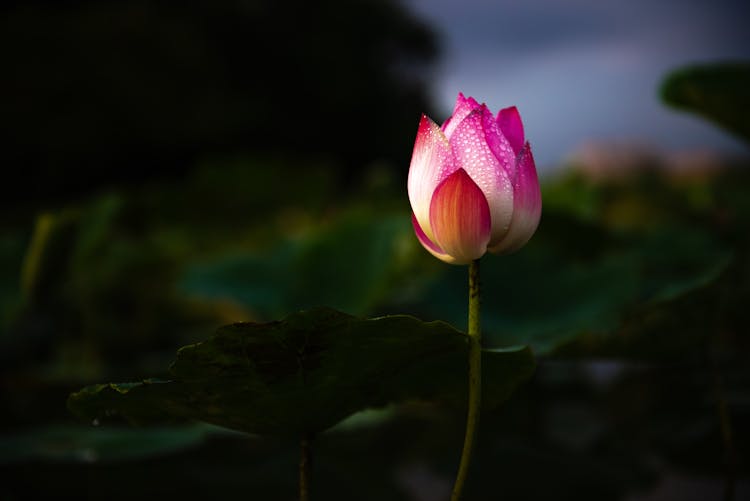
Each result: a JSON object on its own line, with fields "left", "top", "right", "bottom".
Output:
{"left": 0, "top": 0, "right": 750, "bottom": 501}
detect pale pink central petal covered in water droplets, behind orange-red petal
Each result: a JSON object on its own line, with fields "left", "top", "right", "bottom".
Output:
{"left": 450, "top": 106, "right": 513, "bottom": 245}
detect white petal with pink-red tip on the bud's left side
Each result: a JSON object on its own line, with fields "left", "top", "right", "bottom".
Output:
{"left": 407, "top": 115, "right": 456, "bottom": 244}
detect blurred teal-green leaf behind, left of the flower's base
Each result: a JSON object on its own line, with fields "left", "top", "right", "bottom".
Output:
{"left": 180, "top": 213, "right": 416, "bottom": 319}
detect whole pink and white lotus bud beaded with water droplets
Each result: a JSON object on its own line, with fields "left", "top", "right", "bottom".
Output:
{"left": 408, "top": 94, "right": 542, "bottom": 264}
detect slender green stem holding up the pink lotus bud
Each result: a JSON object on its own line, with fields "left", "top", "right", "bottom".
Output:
{"left": 451, "top": 259, "right": 482, "bottom": 501}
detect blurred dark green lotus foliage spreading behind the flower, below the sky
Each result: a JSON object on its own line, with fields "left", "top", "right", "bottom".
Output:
{"left": 0, "top": 151, "right": 750, "bottom": 500}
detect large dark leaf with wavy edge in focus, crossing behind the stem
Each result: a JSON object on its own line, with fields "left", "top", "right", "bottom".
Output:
{"left": 68, "top": 309, "right": 534, "bottom": 436}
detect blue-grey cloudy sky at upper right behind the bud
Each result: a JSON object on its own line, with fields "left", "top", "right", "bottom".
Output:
{"left": 404, "top": 0, "right": 750, "bottom": 170}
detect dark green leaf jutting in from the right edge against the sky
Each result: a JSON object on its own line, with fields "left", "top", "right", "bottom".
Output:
{"left": 661, "top": 61, "right": 750, "bottom": 141}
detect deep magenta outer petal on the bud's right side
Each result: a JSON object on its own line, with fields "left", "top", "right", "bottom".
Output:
{"left": 489, "top": 143, "right": 542, "bottom": 254}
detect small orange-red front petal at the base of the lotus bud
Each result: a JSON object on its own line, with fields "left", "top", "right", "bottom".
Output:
{"left": 428, "top": 169, "right": 492, "bottom": 264}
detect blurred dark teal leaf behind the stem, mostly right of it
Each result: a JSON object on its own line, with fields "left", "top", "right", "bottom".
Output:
{"left": 409, "top": 216, "right": 732, "bottom": 358}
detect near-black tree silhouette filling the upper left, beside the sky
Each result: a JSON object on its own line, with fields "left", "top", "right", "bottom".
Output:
{"left": 0, "top": 0, "right": 437, "bottom": 207}
